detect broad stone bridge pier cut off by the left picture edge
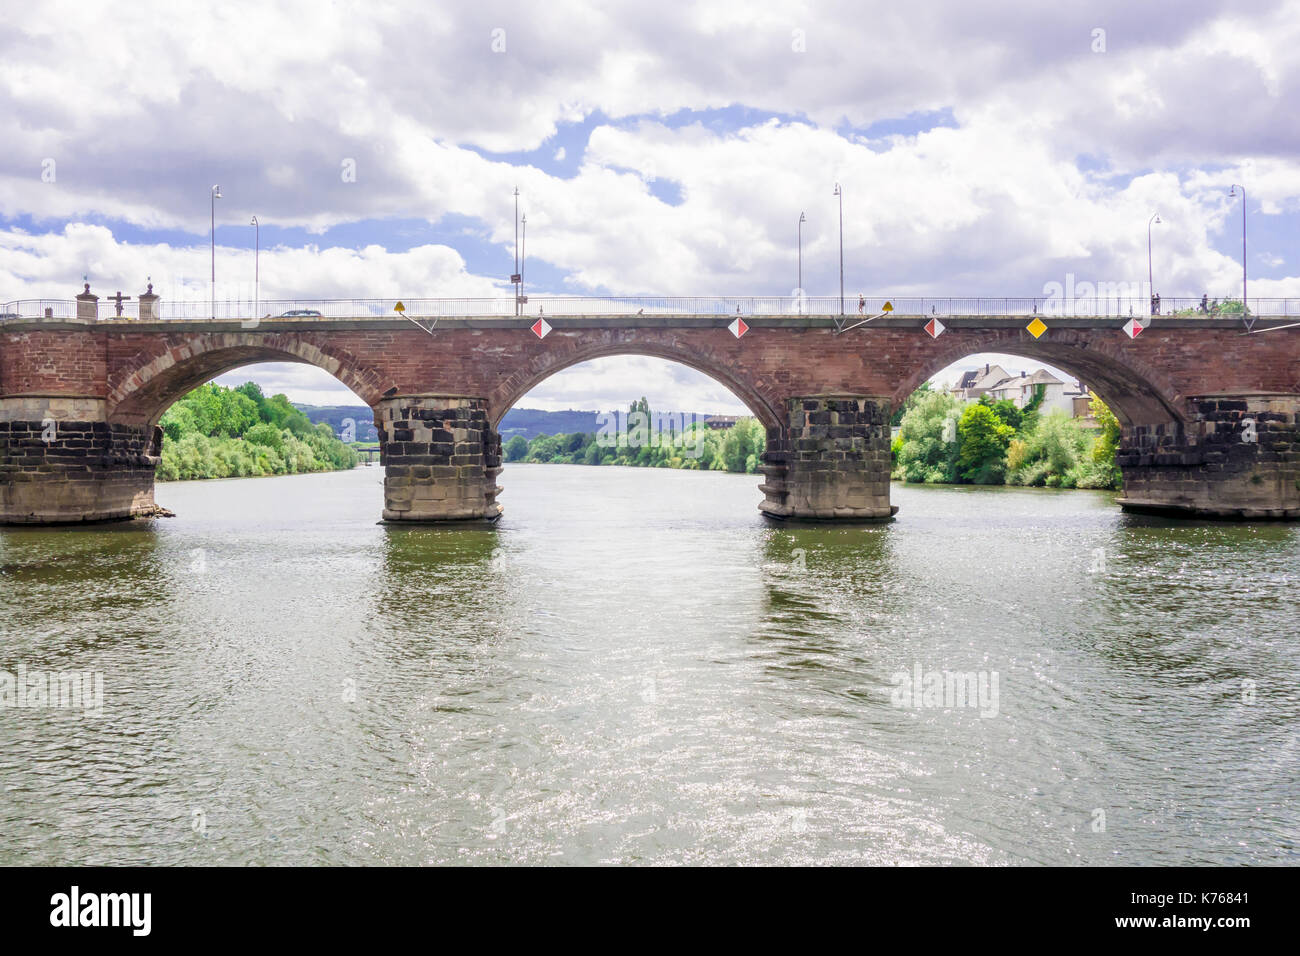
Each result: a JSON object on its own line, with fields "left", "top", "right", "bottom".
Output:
{"left": 0, "top": 397, "right": 161, "bottom": 524}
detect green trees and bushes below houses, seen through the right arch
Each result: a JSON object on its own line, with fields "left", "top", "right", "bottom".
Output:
{"left": 892, "top": 382, "right": 1121, "bottom": 488}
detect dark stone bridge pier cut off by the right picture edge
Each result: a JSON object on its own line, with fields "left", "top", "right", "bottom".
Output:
{"left": 1118, "top": 394, "right": 1300, "bottom": 519}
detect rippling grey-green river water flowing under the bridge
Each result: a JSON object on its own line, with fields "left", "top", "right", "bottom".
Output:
{"left": 0, "top": 464, "right": 1300, "bottom": 865}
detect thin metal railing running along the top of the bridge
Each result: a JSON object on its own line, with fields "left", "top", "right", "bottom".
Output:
{"left": 0, "top": 294, "right": 1300, "bottom": 321}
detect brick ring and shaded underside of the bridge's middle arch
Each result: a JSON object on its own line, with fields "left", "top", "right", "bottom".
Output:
{"left": 488, "top": 342, "right": 785, "bottom": 429}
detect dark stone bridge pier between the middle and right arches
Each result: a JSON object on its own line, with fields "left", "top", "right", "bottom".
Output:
{"left": 759, "top": 395, "right": 898, "bottom": 520}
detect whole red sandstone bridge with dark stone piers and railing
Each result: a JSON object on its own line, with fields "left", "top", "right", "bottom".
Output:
{"left": 0, "top": 291, "right": 1300, "bottom": 524}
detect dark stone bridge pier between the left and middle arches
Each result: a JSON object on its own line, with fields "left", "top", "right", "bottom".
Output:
{"left": 374, "top": 395, "right": 502, "bottom": 522}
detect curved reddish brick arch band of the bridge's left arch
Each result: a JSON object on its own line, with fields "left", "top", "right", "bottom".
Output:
{"left": 108, "top": 333, "right": 387, "bottom": 425}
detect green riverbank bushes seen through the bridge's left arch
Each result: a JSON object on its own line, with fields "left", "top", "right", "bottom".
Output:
{"left": 157, "top": 382, "right": 360, "bottom": 481}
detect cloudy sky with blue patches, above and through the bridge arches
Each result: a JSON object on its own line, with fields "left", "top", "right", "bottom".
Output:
{"left": 0, "top": 0, "right": 1300, "bottom": 411}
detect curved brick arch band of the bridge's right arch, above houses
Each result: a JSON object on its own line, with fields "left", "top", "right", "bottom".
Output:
{"left": 891, "top": 329, "right": 1192, "bottom": 425}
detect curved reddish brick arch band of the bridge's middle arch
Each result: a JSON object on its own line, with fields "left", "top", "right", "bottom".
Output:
{"left": 488, "top": 337, "right": 785, "bottom": 428}
